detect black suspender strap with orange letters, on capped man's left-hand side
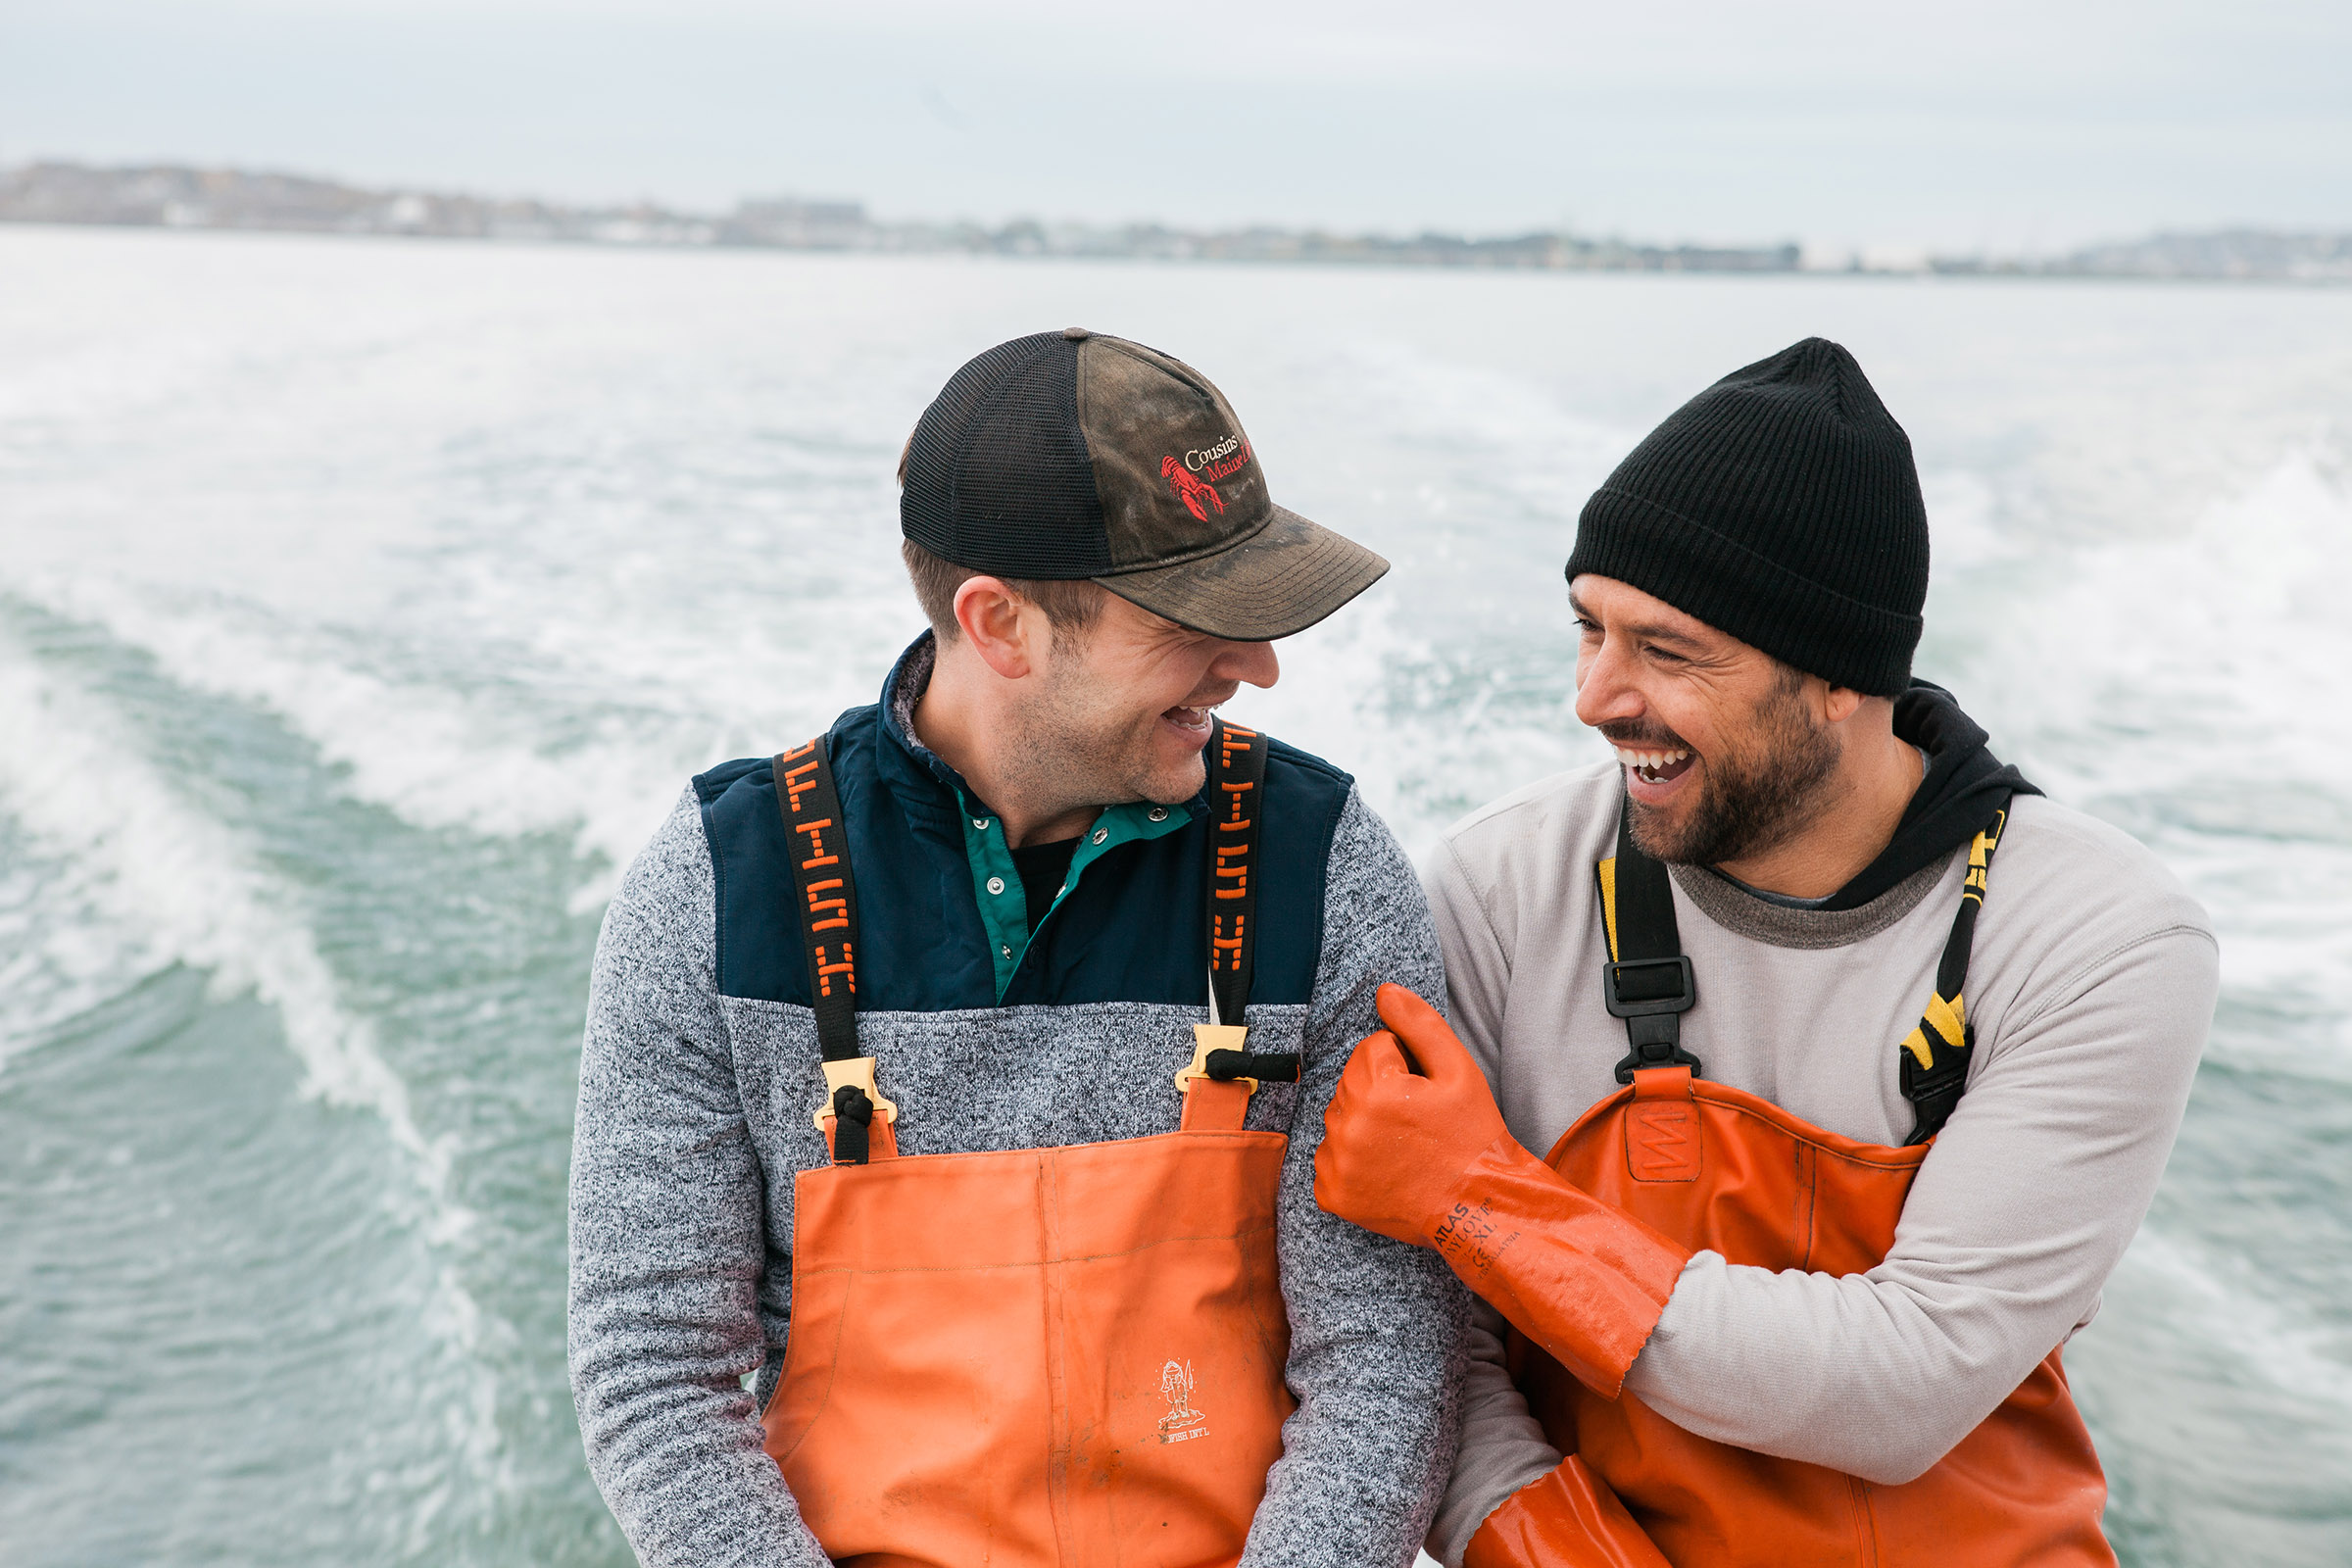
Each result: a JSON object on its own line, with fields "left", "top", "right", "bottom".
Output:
{"left": 776, "top": 736, "right": 875, "bottom": 1166}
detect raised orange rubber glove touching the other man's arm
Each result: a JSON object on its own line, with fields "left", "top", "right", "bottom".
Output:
{"left": 1315, "top": 985, "right": 1691, "bottom": 1398}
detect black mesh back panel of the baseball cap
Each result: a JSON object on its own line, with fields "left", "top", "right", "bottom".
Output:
{"left": 899, "top": 331, "right": 1112, "bottom": 578}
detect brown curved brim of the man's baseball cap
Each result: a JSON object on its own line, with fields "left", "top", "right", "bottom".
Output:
{"left": 1094, "top": 506, "right": 1388, "bottom": 642}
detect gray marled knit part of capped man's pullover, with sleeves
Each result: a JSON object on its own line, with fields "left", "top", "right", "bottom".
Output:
{"left": 569, "top": 775, "right": 1465, "bottom": 1568}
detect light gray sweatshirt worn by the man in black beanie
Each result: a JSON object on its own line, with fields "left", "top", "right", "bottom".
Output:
{"left": 1423, "top": 764, "right": 2218, "bottom": 1563}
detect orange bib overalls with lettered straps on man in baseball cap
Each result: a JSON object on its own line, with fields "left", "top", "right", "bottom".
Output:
{"left": 762, "top": 726, "right": 1298, "bottom": 1568}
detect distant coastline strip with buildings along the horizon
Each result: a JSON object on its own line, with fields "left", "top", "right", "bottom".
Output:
{"left": 0, "top": 160, "right": 2352, "bottom": 282}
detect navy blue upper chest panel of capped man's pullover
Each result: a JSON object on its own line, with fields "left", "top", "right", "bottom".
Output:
{"left": 694, "top": 708, "right": 1352, "bottom": 1013}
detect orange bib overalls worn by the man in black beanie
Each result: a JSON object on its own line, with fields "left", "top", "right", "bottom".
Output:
{"left": 1465, "top": 811, "right": 2115, "bottom": 1568}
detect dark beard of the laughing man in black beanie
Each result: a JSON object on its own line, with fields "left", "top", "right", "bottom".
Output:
{"left": 1625, "top": 684, "right": 1839, "bottom": 865}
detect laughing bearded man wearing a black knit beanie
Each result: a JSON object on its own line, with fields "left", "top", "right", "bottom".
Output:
{"left": 1315, "top": 338, "right": 2218, "bottom": 1568}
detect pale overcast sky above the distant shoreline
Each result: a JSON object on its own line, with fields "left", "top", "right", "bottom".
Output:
{"left": 0, "top": 0, "right": 2352, "bottom": 252}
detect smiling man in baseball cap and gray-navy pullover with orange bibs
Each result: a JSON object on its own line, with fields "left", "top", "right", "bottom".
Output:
{"left": 569, "top": 329, "right": 1468, "bottom": 1568}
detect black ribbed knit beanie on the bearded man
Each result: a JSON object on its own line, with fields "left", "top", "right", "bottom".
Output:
{"left": 1569, "top": 338, "right": 1927, "bottom": 696}
